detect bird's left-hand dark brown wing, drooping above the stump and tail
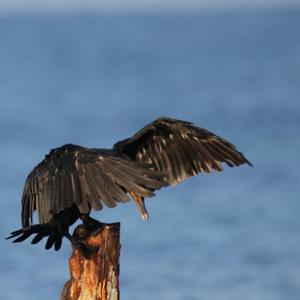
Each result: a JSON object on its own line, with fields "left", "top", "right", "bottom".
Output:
{"left": 22, "top": 145, "right": 164, "bottom": 228}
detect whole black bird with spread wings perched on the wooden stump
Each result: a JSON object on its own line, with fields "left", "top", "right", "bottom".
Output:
{"left": 8, "top": 117, "right": 252, "bottom": 250}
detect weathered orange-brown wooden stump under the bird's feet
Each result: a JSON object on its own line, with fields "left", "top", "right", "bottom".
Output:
{"left": 60, "top": 223, "right": 120, "bottom": 300}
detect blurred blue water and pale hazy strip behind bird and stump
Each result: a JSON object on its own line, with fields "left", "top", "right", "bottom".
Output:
{"left": 0, "top": 0, "right": 300, "bottom": 300}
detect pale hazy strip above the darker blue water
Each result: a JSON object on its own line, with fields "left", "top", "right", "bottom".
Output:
{"left": 0, "top": 0, "right": 300, "bottom": 15}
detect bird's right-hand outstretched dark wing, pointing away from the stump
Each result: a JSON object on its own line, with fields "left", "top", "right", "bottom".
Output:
{"left": 114, "top": 117, "right": 252, "bottom": 184}
